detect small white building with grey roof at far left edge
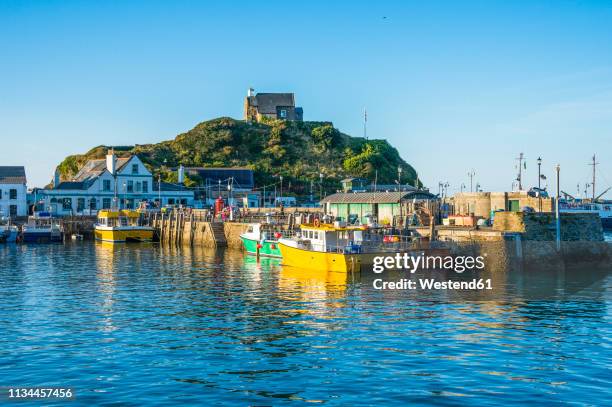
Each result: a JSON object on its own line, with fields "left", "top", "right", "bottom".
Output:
{"left": 0, "top": 167, "right": 28, "bottom": 217}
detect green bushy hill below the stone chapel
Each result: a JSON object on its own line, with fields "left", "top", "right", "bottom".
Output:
{"left": 58, "top": 117, "right": 416, "bottom": 194}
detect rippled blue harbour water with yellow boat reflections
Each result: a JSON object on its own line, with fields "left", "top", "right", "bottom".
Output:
{"left": 0, "top": 242, "right": 612, "bottom": 405}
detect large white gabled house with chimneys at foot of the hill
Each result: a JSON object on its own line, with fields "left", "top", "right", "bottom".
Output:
{"left": 35, "top": 153, "right": 194, "bottom": 216}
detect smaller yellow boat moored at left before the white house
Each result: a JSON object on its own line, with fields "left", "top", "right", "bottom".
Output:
{"left": 94, "top": 209, "right": 153, "bottom": 243}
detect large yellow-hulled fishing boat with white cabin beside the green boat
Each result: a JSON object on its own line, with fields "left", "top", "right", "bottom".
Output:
{"left": 278, "top": 222, "right": 449, "bottom": 273}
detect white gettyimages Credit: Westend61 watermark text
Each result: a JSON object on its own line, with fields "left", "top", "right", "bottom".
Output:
{"left": 372, "top": 253, "right": 493, "bottom": 290}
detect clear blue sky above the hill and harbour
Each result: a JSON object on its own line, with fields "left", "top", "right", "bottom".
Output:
{"left": 0, "top": 0, "right": 612, "bottom": 197}
